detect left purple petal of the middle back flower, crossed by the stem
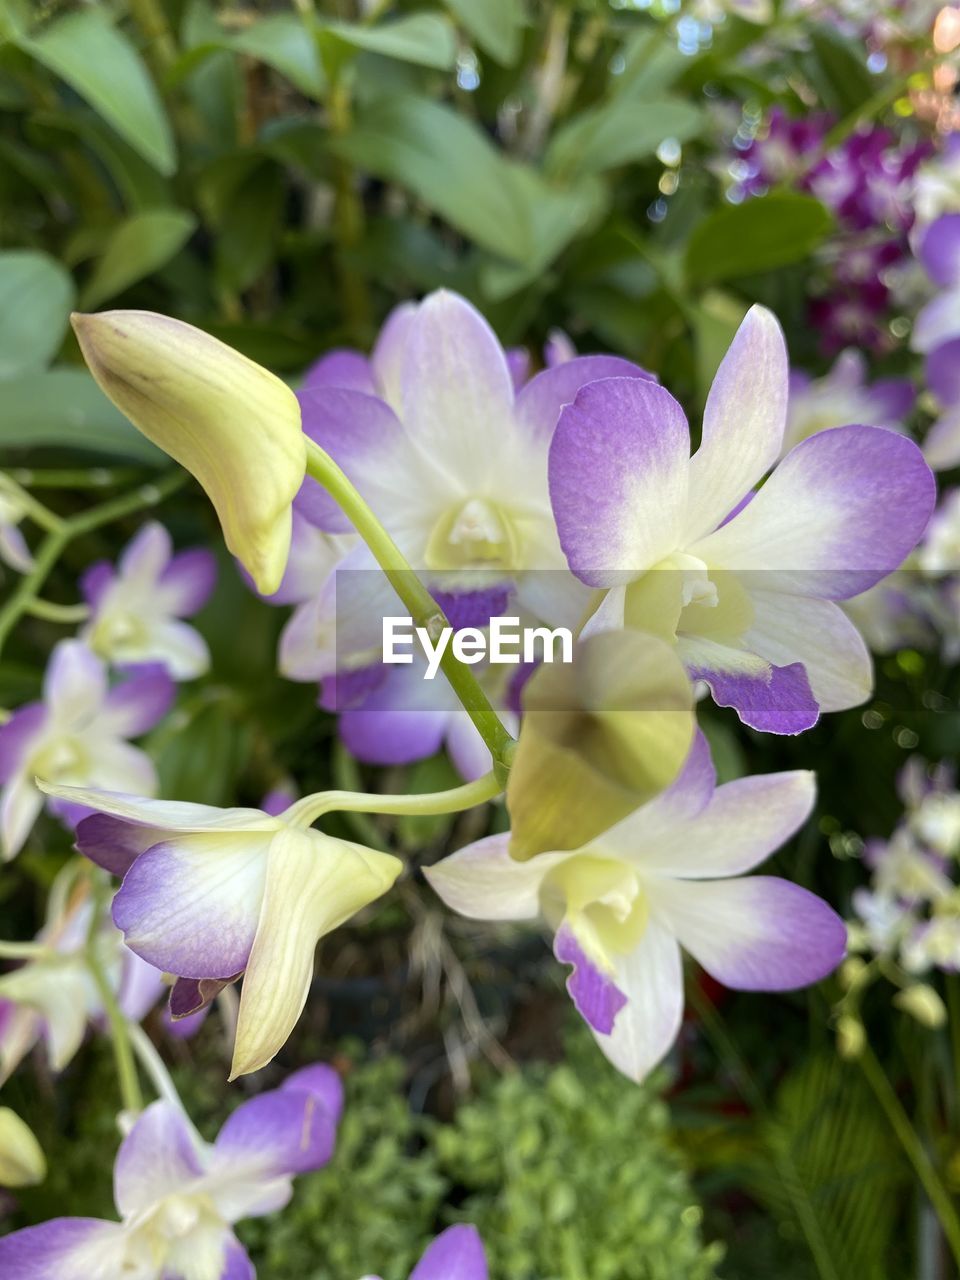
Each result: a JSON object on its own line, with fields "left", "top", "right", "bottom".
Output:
{"left": 293, "top": 387, "right": 412, "bottom": 534}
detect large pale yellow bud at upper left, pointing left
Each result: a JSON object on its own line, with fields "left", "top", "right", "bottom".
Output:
{"left": 72, "top": 311, "right": 306, "bottom": 595}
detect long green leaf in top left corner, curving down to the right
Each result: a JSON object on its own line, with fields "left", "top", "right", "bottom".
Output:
{"left": 15, "top": 9, "right": 177, "bottom": 174}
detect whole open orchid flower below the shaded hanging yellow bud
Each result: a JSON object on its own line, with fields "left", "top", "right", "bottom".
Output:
{"left": 424, "top": 736, "right": 846, "bottom": 1080}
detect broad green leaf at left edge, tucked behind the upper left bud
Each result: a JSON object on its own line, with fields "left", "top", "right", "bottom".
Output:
{"left": 0, "top": 369, "right": 164, "bottom": 466}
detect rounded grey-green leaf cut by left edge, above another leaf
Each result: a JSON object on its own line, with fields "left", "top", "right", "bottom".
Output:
{"left": 0, "top": 248, "right": 74, "bottom": 376}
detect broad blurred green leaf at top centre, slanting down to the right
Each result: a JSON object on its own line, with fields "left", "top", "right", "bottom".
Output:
{"left": 330, "top": 96, "right": 534, "bottom": 262}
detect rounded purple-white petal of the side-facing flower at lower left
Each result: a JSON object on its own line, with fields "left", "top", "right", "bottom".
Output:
{"left": 113, "top": 832, "right": 273, "bottom": 978}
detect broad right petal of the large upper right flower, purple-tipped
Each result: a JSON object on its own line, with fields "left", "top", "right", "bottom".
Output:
{"left": 689, "top": 426, "right": 937, "bottom": 600}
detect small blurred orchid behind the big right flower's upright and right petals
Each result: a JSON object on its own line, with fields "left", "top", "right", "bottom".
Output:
{"left": 782, "top": 349, "right": 915, "bottom": 453}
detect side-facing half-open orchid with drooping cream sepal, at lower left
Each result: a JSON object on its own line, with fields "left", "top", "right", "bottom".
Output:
{"left": 42, "top": 787, "right": 403, "bottom": 1078}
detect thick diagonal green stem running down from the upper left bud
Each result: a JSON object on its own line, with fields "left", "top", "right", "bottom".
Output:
{"left": 307, "top": 440, "right": 513, "bottom": 782}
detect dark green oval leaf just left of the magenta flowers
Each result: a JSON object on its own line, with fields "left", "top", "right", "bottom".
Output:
{"left": 686, "top": 195, "right": 832, "bottom": 285}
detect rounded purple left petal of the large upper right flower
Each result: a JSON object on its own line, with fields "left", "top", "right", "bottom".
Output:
{"left": 549, "top": 366, "right": 690, "bottom": 586}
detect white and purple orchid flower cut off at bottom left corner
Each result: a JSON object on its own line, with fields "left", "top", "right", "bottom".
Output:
{"left": 0, "top": 1065, "right": 343, "bottom": 1280}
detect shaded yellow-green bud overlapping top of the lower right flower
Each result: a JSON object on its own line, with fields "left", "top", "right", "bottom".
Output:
{"left": 507, "top": 631, "right": 695, "bottom": 860}
